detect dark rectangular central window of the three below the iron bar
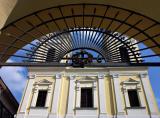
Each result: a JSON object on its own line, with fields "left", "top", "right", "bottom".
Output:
{"left": 81, "top": 88, "right": 93, "bottom": 108}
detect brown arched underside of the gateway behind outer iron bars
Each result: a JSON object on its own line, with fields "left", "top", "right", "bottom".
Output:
{"left": 0, "top": 4, "right": 160, "bottom": 66}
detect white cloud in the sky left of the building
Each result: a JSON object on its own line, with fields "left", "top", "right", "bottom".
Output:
{"left": 0, "top": 59, "right": 26, "bottom": 96}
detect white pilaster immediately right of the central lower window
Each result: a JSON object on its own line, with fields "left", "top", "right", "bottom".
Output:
{"left": 98, "top": 75, "right": 107, "bottom": 118}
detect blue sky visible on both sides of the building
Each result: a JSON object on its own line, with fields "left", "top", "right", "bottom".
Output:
{"left": 0, "top": 35, "right": 160, "bottom": 109}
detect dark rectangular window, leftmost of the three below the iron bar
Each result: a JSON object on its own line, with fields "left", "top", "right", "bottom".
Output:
{"left": 36, "top": 90, "right": 47, "bottom": 107}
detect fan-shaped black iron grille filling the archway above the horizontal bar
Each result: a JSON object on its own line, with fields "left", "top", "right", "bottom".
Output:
{"left": 0, "top": 3, "right": 160, "bottom": 66}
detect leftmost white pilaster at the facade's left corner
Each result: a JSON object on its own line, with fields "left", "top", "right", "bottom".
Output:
{"left": 16, "top": 75, "right": 35, "bottom": 118}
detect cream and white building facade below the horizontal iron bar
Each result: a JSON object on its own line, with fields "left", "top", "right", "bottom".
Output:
{"left": 17, "top": 67, "right": 160, "bottom": 118}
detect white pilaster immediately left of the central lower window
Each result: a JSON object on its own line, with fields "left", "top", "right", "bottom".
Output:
{"left": 66, "top": 76, "right": 75, "bottom": 118}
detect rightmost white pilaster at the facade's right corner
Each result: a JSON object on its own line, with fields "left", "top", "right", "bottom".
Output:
{"left": 140, "top": 73, "right": 159, "bottom": 118}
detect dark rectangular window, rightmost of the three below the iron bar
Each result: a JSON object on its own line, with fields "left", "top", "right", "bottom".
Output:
{"left": 128, "top": 90, "right": 140, "bottom": 107}
